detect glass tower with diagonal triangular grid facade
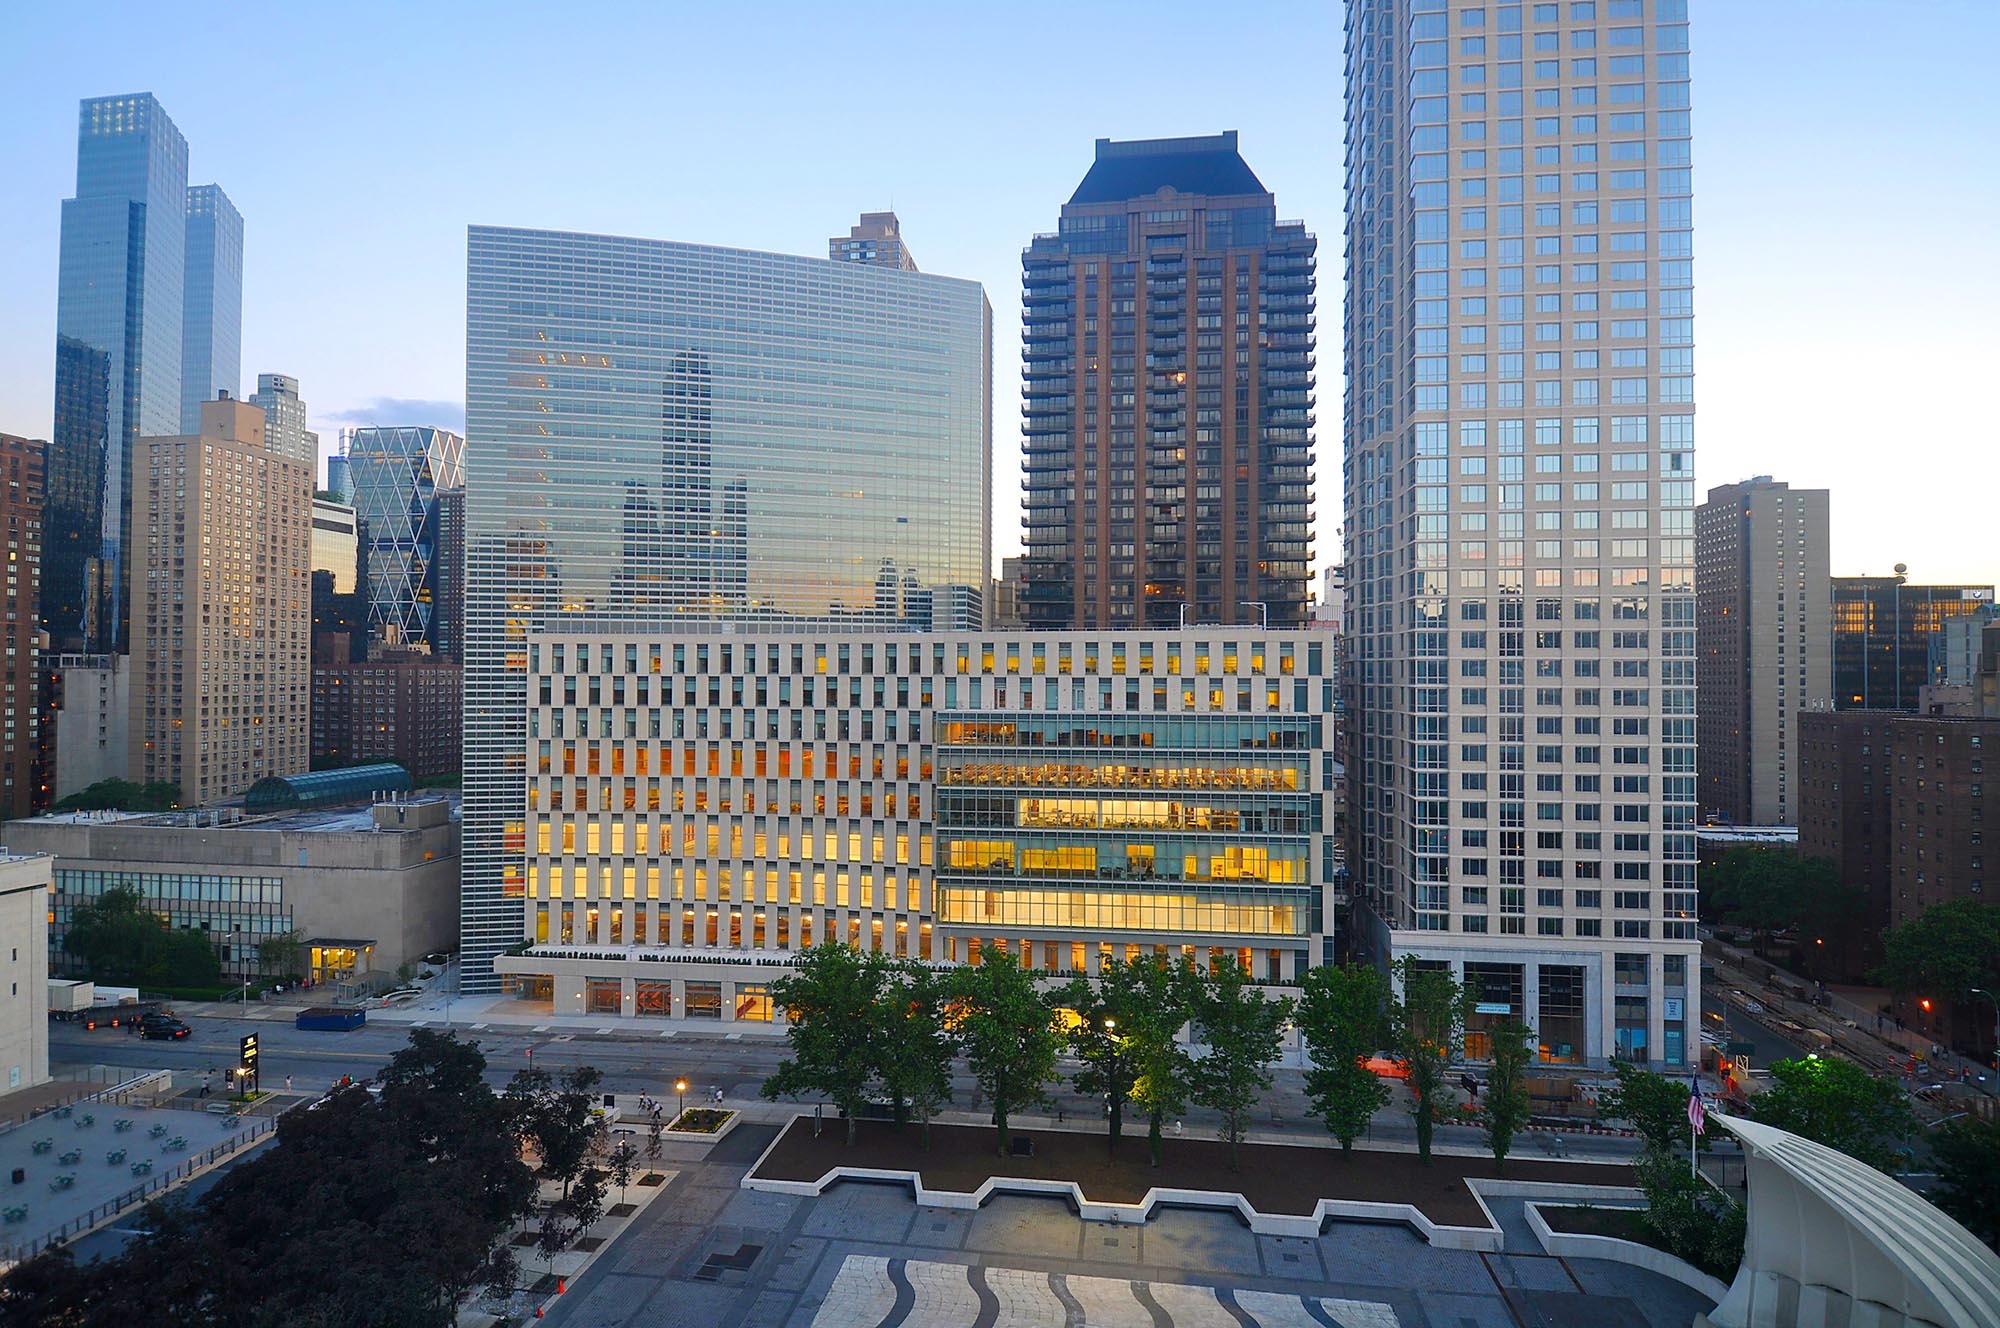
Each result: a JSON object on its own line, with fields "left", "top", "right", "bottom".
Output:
{"left": 348, "top": 426, "right": 466, "bottom": 646}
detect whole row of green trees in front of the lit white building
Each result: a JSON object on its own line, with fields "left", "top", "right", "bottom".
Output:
{"left": 764, "top": 944, "right": 1534, "bottom": 1166}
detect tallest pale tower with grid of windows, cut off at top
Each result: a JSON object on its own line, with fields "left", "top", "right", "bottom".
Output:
{"left": 1344, "top": 0, "right": 1700, "bottom": 1066}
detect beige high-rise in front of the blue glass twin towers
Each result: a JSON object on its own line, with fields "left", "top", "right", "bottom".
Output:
{"left": 130, "top": 400, "right": 312, "bottom": 806}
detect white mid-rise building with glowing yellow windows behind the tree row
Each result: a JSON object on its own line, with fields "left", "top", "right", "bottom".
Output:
{"left": 496, "top": 628, "right": 1342, "bottom": 1020}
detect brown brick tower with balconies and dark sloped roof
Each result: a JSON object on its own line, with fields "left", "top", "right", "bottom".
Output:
{"left": 1022, "top": 130, "right": 1316, "bottom": 628}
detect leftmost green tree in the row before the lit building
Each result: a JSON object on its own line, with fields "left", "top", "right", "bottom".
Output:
{"left": 762, "top": 942, "right": 888, "bottom": 1146}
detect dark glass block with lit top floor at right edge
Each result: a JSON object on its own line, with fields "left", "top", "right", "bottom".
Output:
{"left": 1832, "top": 562, "right": 1994, "bottom": 710}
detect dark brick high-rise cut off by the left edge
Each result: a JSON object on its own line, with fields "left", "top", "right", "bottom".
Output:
{"left": 0, "top": 434, "right": 50, "bottom": 816}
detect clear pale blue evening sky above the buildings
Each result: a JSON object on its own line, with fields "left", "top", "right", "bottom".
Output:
{"left": 0, "top": 0, "right": 2000, "bottom": 580}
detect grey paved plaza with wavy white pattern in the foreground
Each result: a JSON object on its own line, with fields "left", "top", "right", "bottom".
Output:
{"left": 548, "top": 1124, "right": 1710, "bottom": 1328}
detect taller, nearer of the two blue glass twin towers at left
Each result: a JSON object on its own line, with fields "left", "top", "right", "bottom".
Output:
{"left": 42, "top": 92, "right": 188, "bottom": 652}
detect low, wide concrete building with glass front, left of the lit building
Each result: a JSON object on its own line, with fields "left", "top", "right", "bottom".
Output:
{"left": 4, "top": 798, "right": 458, "bottom": 980}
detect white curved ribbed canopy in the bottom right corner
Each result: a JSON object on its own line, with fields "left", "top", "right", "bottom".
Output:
{"left": 1708, "top": 1116, "right": 2000, "bottom": 1328}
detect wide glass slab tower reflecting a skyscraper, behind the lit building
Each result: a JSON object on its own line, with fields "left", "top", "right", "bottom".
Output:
{"left": 460, "top": 226, "right": 992, "bottom": 990}
